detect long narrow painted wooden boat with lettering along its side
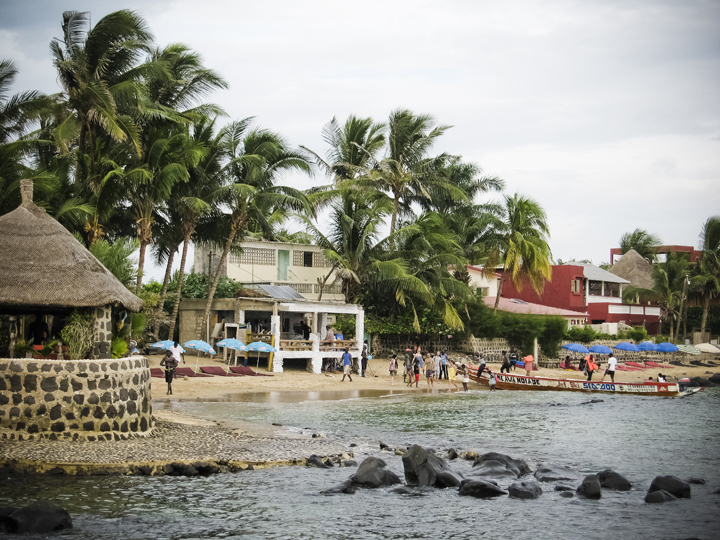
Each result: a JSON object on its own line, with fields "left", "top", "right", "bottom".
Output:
{"left": 470, "top": 373, "right": 703, "bottom": 397}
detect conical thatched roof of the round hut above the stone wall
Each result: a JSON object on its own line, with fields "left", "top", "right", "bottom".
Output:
{"left": 0, "top": 180, "right": 143, "bottom": 311}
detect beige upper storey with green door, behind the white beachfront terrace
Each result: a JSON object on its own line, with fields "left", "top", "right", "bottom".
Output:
{"left": 194, "top": 239, "right": 344, "bottom": 301}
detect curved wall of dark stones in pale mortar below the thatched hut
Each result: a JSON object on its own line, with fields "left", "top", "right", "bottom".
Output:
{"left": 0, "top": 356, "right": 153, "bottom": 441}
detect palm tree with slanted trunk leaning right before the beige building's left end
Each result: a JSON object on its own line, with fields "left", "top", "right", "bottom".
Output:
{"left": 203, "top": 118, "right": 312, "bottom": 338}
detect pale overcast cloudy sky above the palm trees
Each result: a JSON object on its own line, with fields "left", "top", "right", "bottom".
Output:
{"left": 0, "top": 0, "right": 720, "bottom": 276}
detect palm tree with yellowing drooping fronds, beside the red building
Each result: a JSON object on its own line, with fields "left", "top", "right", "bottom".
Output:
{"left": 487, "top": 193, "right": 552, "bottom": 312}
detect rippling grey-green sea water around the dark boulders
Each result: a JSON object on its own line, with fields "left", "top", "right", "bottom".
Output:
{"left": 0, "top": 389, "right": 720, "bottom": 540}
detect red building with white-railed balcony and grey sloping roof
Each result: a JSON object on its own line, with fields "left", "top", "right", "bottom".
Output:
{"left": 501, "top": 263, "right": 660, "bottom": 334}
